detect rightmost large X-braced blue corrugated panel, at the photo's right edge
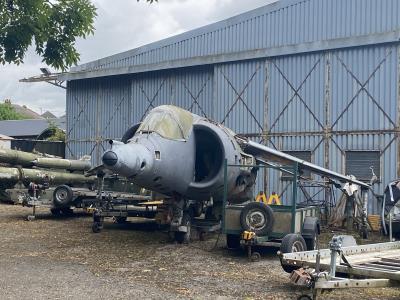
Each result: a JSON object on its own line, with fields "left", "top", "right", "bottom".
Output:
{"left": 331, "top": 45, "right": 397, "bottom": 130}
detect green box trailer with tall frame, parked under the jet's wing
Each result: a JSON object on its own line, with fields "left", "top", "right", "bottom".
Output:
{"left": 222, "top": 162, "right": 320, "bottom": 261}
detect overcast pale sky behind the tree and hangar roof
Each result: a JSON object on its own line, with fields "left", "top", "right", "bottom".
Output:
{"left": 0, "top": 0, "right": 276, "bottom": 116}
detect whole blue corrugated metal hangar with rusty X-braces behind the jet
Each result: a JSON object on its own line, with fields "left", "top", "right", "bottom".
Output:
{"left": 61, "top": 0, "right": 400, "bottom": 211}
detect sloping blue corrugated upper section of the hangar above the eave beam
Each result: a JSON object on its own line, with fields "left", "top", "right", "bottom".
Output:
{"left": 72, "top": 0, "right": 400, "bottom": 77}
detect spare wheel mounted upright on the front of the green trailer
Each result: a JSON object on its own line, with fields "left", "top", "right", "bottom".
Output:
{"left": 240, "top": 202, "right": 274, "bottom": 235}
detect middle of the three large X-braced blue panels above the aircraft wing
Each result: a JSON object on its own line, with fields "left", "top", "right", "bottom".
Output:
{"left": 268, "top": 53, "right": 325, "bottom": 132}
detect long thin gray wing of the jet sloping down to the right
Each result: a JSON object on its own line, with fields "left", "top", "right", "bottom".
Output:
{"left": 235, "top": 136, "right": 370, "bottom": 189}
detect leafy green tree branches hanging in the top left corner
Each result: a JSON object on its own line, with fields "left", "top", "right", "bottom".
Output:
{"left": 0, "top": 0, "right": 96, "bottom": 70}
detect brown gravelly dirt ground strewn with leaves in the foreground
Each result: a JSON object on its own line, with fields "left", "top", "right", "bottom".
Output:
{"left": 0, "top": 204, "right": 400, "bottom": 299}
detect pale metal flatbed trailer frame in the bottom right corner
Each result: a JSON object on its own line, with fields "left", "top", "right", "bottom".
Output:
{"left": 281, "top": 236, "right": 400, "bottom": 299}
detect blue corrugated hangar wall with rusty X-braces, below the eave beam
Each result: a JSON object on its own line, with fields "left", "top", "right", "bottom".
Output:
{"left": 67, "top": 41, "right": 400, "bottom": 213}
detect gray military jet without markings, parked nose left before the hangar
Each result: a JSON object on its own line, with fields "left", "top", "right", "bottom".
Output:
{"left": 102, "top": 105, "right": 368, "bottom": 241}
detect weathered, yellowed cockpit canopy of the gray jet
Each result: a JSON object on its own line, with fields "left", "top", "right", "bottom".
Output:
{"left": 138, "top": 105, "right": 193, "bottom": 141}
